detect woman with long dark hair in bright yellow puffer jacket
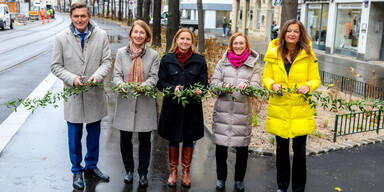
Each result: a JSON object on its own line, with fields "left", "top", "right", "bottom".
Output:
{"left": 263, "top": 19, "right": 321, "bottom": 192}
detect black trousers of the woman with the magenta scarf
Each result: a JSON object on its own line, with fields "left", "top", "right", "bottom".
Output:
{"left": 216, "top": 145, "right": 248, "bottom": 181}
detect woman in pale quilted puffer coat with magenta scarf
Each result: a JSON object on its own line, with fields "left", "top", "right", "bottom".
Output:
{"left": 211, "top": 33, "right": 261, "bottom": 191}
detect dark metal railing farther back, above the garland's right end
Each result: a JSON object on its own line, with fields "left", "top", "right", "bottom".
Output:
{"left": 320, "top": 71, "right": 384, "bottom": 100}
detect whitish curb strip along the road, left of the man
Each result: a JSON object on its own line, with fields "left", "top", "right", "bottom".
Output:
{"left": 0, "top": 73, "right": 57, "bottom": 154}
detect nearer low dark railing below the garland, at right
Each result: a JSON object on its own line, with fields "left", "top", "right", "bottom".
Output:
{"left": 333, "top": 110, "right": 384, "bottom": 142}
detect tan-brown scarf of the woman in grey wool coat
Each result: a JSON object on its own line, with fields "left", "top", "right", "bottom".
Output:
{"left": 128, "top": 41, "right": 144, "bottom": 83}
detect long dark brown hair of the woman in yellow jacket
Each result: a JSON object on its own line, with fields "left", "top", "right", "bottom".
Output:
{"left": 278, "top": 19, "right": 314, "bottom": 61}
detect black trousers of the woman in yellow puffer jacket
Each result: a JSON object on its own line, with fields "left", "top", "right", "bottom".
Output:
{"left": 276, "top": 135, "right": 307, "bottom": 192}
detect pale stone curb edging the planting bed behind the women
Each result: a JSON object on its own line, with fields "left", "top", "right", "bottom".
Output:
{"left": 204, "top": 124, "right": 384, "bottom": 157}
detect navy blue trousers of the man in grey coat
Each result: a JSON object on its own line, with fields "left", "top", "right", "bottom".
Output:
{"left": 67, "top": 121, "right": 101, "bottom": 174}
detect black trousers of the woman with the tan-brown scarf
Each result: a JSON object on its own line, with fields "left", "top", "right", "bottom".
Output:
{"left": 120, "top": 130, "right": 152, "bottom": 176}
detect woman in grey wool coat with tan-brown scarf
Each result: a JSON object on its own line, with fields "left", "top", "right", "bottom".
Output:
{"left": 113, "top": 20, "right": 160, "bottom": 187}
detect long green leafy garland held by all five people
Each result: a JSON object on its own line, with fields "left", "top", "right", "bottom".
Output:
{"left": 3, "top": 82, "right": 384, "bottom": 113}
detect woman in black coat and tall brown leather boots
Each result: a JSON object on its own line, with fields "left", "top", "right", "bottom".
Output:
{"left": 157, "top": 28, "right": 208, "bottom": 187}
